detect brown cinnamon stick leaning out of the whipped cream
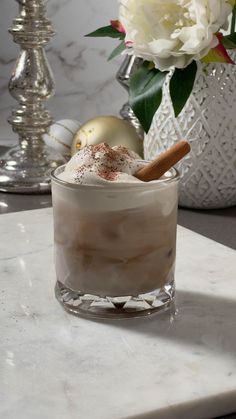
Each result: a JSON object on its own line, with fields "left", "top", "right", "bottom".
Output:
{"left": 135, "top": 140, "right": 190, "bottom": 182}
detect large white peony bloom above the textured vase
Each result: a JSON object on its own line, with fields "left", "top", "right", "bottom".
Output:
{"left": 119, "top": 0, "right": 232, "bottom": 71}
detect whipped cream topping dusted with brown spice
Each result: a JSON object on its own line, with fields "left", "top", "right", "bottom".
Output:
{"left": 58, "top": 143, "right": 144, "bottom": 185}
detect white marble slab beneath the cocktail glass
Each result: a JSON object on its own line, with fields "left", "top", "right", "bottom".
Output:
{"left": 0, "top": 209, "right": 236, "bottom": 419}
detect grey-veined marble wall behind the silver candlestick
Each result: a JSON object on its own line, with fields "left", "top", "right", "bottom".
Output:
{"left": 0, "top": 0, "right": 127, "bottom": 136}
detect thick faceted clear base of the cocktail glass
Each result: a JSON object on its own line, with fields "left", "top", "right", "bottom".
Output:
{"left": 55, "top": 281, "right": 175, "bottom": 319}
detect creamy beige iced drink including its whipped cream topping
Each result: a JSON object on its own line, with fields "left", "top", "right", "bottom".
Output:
{"left": 52, "top": 144, "right": 178, "bottom": 311}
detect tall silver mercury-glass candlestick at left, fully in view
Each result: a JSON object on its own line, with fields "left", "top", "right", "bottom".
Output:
{"left": 0, "top": 0, "right": 64, "bottom": 193}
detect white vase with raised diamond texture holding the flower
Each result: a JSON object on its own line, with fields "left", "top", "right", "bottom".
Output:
{"left": 144, "top": 57, "right": 236, "bottom": 209}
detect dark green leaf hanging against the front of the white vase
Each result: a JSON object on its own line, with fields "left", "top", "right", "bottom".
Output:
{"left": 170, "top": 61, "right": 197, "bottom": 117}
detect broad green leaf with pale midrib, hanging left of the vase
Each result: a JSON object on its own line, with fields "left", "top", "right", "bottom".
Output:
{"left": 129, "top": 61, "right": 167, "bottom": 132}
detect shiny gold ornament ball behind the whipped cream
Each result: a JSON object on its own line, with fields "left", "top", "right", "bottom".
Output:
{"left": 71, "top": 116, "right": 143, "bottom": 157}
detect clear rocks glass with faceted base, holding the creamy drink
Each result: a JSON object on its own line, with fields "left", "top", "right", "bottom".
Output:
{"left": 52, "top": 166, "right": 179, "bottom": 318}
